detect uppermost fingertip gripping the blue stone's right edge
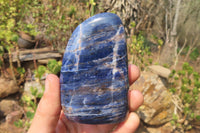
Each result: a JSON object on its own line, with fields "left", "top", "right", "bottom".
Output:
{"left": 128, "top": 64, "right": 140, "bottom": 85}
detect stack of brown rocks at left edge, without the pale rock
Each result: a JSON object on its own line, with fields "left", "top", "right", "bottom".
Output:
{"left": 0, "top": 77, "right": 23, "bottom": 133}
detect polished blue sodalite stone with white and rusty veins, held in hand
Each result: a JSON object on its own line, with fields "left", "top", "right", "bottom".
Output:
{"left": 60, "top": 13, "right": 129, "bottom": 124}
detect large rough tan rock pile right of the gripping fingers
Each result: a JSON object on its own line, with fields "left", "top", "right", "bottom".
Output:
{"left": 130, "top": 65, "right": 200, "bottom": 133}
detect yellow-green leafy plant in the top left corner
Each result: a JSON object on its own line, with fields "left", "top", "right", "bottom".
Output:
{"left": 0, "top": 0, "right": 37, "bottom": 83}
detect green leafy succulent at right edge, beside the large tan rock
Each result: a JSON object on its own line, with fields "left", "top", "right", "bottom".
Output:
{"left": 169, "top": 62, "right": 200, "bottom": 130}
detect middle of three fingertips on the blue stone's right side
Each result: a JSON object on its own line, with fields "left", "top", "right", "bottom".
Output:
{"left": 128, "top": 90, "right": 144, "bottom": 112}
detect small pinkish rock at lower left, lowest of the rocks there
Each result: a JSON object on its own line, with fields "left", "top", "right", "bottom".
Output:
{"left": 6, "top": 110, "right": 23, "bottom": 124}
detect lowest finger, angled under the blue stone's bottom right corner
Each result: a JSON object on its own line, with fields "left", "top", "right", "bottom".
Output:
{"left": 113, "top": 112, "right": 140, "bottom": 133}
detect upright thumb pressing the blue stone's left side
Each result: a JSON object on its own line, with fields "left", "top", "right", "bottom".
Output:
{"left": 28, "top": 74, "right": 61, "bottom": 133}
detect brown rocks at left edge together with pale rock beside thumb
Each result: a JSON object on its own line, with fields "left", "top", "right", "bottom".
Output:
{"left": 0, "top": 74, "right": 44, "bottom": 133}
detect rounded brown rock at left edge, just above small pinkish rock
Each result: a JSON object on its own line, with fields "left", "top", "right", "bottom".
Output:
{"left": 0, "top": 99, "right": 21, "bottom": 116}
